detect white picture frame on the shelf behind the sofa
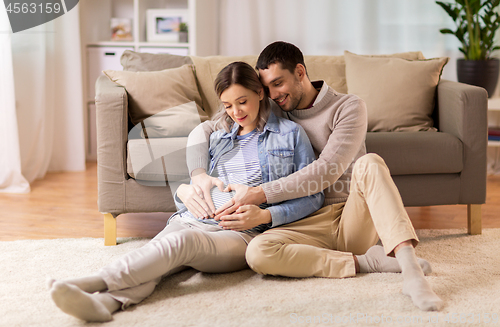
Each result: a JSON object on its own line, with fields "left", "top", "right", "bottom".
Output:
{"left": 146, "top": 9, "right": 189, "bottom": 43}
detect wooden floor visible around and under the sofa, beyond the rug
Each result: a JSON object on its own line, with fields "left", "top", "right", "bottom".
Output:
{"left": 0, "top": 163, "right": 500, "bottom": 241}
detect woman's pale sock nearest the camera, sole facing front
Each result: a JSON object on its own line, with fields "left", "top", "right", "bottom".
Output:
{"left": 50, "top": 282, "right": 112, "bottom": 322}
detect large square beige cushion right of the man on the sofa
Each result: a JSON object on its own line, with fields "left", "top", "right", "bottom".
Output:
{"left": 345, "top": 51, "right": 448, "bottom": 132}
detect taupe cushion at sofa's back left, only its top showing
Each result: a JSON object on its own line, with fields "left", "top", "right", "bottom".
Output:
{"left": 120, "top": 50, "right": 193, "bottom": 72}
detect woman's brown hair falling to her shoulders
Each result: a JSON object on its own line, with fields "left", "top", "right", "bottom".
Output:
{"left": 212, "top": 61, "right": 271, "bottom": 133}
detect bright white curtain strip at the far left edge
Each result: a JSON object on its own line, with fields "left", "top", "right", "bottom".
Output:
{"left": 0, "top": 5, "right": 30, "bottom": 193}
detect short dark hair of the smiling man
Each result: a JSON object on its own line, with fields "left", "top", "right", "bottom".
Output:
{"left": 255, "top": 41, "right": 307, "bottom": 74}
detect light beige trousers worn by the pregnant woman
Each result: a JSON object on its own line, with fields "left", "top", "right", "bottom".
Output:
{"left": 99, "top": 215, "right": 252, "bottom": 309}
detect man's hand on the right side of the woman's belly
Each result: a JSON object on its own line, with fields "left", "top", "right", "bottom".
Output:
{"left": 215, "top": 184, "right": 267, "bottom": 220}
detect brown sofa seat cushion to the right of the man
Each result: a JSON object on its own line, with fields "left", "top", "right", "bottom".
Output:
{"left": 366, "top": 132, "right": 463, "bottom": 176}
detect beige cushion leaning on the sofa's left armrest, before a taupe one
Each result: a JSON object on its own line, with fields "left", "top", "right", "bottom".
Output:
{"left": 104, "top": 65, "right": 208, "bottom": 128}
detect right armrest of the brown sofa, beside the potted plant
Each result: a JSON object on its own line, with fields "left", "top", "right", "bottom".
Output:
{"left": 437, "top": 80, "right": 488, "bottom": 204}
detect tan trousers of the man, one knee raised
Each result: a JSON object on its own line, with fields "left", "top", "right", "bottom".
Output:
{"left": 246, "top": 153, "right": 418, "bottom": 278}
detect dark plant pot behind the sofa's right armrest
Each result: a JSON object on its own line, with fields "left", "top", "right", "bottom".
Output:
{"left": 457, "top": 58, "right": 500, "bottom": 98}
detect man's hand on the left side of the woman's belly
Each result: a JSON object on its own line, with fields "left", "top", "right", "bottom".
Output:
{"left": 185, "top": 168, "right": 224, "bottom": 218}
